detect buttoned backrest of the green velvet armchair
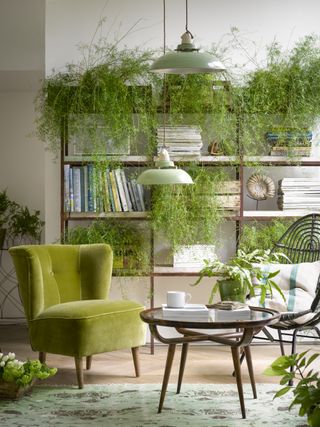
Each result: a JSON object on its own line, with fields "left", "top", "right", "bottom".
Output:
{"left": 9, "top": 244, "right": 113, "bottom": 320}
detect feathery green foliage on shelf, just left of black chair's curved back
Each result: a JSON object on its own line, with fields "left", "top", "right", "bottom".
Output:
{"left": 239, "top": 219, "right": 293, "bottom": 252}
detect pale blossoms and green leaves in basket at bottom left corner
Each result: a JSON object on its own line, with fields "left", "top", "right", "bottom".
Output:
{"left": 0, "top": 353, "right": 57, "bottom": 386}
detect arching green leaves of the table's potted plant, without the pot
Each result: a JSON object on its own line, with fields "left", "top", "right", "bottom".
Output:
{"left": 193, "top": 250, "right": 287, "bottom": 304}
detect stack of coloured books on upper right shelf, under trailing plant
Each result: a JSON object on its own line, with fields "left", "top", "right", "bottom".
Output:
{"left": 265, "top": 130, "right": 312, "bottom": 157}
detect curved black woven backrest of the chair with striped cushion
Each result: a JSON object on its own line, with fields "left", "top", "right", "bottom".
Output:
{"left": 272, "top": 213, "right": 320, "bottom": 311}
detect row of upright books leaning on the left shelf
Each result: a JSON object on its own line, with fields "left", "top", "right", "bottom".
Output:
{"left": 64, "top": 164, "right": 145, "bottom": 212}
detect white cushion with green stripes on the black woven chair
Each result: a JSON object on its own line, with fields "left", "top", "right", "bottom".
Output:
{"left": 249, "top": 261, "right": 320, "bottom": 324}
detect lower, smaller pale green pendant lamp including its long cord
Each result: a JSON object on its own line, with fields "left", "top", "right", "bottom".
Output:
{"left": 137, "top": 0, "right": 193, "bottom": 185}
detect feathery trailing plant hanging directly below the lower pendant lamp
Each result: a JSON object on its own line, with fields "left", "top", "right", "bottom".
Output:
{"left": 151, "top": 166, "right": 226, "bottom": 251}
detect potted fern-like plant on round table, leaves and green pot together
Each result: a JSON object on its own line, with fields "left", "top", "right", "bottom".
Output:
{"left": 194, "top": 249, "right": 286, "bottom": 304}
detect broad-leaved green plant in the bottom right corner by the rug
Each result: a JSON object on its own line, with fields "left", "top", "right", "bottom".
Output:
{"left": 264, "top": 351, "right": 320, "bottom": 427}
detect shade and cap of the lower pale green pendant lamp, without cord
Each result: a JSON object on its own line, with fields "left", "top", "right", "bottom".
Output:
{"left": 137, "top": 148, "right": 193, "bottom": 185}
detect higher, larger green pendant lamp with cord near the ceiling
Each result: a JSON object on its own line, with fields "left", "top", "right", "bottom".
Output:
{"left": 150, "top": 0, "right": 226, "bottom": 74}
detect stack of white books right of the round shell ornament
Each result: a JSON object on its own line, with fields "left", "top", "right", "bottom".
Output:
{"left": 278, "top": 178, "right": 320, "bottom": 211}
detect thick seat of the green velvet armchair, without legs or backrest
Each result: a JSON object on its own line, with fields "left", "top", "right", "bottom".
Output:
{"left": 29, "top": 299, "right": 146, "bottom": 357}
